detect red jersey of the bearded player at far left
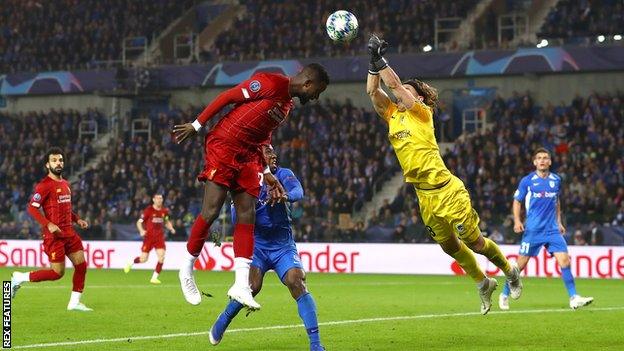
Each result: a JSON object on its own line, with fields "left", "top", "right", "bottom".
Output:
{"left": 29, "top": 176, "right": 74, "bottom": 238}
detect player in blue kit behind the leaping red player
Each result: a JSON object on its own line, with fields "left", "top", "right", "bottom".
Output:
{"left": 208, "top": 145, "right": 325, "bottom": 351}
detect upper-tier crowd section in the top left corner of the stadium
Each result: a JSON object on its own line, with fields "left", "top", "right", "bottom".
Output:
{"left": 0, "top": 0, "right": 195, "bottom": 73}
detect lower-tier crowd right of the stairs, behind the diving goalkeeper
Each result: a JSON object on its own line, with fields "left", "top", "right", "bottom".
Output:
{"left": 382, "top": 93, "right": 624, "bottom": 244}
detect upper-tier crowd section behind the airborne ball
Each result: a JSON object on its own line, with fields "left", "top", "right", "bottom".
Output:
{"left": 208, "top": 0, "right": 478, "bottom": 60}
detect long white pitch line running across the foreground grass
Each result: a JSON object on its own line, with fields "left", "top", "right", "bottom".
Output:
{"left": 13, "top": 306, "right": 624, "bottom": 349}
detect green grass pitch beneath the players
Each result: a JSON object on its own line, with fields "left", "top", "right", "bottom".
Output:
{"left": 6, "top": 267, "right": 624, "bottom": 351}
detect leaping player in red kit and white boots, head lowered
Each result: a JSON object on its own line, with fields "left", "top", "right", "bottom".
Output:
{"left": 173, "top": 63, "right": 329, "bottom": 310}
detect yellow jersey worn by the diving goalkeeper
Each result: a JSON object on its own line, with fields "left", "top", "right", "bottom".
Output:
{"left": 384, "top": 101, "right": 451, "bottom": 189}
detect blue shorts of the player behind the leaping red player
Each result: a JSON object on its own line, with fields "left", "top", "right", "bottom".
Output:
{"left": 251, "top": 245, "right": 303, "bottom": 282}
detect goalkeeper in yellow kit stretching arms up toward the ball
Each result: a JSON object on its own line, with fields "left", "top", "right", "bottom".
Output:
{"left": 366, "top": 35, "right": 522, "bottom": 314}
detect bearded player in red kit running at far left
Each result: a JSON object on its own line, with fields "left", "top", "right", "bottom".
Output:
{"left": 11, "top": 148, "right": 92, "bottom": 311}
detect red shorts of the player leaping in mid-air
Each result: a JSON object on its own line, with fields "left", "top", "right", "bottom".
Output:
{"left": 197, "top": 134, "right": 264, "bottom": 197}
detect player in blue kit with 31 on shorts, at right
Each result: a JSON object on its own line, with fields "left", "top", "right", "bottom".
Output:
{"left": 498, "top": 148, "right": 594, "bottom": 310}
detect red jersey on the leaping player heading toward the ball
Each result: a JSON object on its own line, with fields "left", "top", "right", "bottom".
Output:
{"left": 211, "top": 73, "right": 293, "bottom": 145}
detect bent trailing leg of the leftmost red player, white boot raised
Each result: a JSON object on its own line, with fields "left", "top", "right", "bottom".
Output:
{"left": 11, "top": 238, "right": 65, "bottom": 298}
